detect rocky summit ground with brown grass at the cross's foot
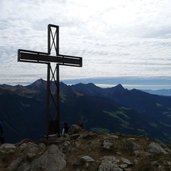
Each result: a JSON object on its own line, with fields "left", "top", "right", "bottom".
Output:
{"left": 0, "top": 125, "right": 171, "bottom": 171}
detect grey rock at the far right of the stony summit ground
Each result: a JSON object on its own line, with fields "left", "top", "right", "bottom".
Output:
{"left": 148, "top": 142, "right": 168, "bottom": 154}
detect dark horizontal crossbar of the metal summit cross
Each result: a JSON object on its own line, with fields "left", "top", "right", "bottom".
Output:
{"left": 18, "top": 49, "right": 82, "bottom": 67}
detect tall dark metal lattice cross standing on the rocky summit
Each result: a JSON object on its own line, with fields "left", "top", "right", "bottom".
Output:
{"left": 18, "top": 24, "right": 82, "bottom": 138}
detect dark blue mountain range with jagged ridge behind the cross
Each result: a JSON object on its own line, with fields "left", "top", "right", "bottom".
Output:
{"left": 0, "top": 79, "right": 171, "bottom": 143}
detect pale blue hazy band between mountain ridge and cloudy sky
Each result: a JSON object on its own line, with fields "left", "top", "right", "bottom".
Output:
{"left": 0, "top": 77, "right": 171, "bottom": 90}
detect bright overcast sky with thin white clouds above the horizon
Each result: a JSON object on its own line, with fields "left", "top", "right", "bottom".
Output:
{"left": 0, "top": 0, "right": 171, "bottom": 84}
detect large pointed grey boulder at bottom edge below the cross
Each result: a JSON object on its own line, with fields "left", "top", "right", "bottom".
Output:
{"left": 30, "top": 145, "right": 66, "bottom": 171}
